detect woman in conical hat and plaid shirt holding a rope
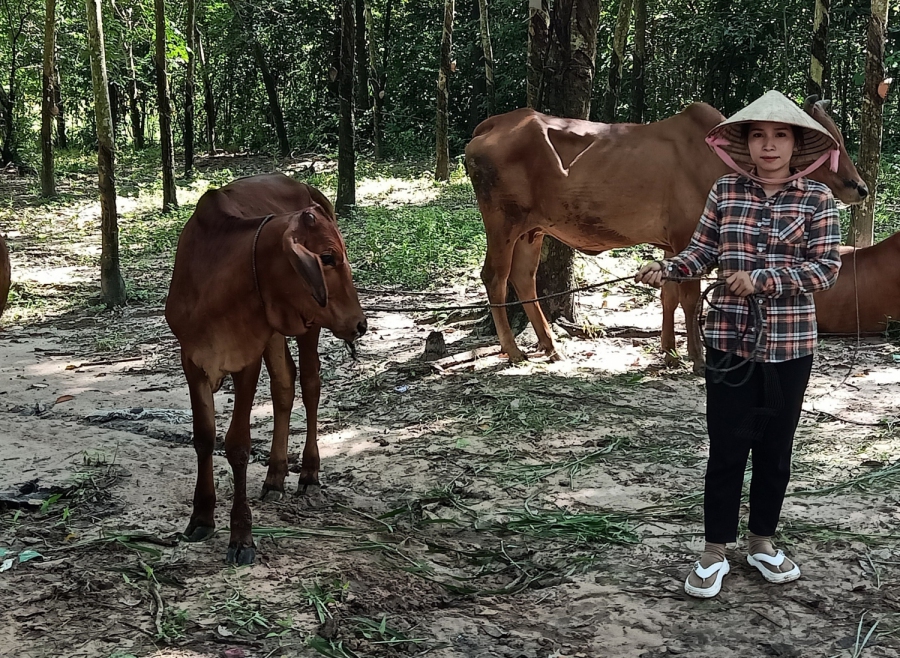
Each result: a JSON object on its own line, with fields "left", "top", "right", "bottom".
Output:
{"left": 635, "top": 91, "right": 841, "bottom": 598}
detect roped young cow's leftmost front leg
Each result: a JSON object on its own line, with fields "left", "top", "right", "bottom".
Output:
{"left": 181, "top": 353, "right": 216, "bottom": 541}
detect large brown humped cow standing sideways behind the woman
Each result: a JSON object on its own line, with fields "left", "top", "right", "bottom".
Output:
{"left": 466, "top": 97, "right": 868, "bottom": 372}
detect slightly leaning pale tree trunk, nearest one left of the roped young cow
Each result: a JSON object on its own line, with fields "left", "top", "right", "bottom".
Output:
{"left": 85, "top": 0, "right": 125, "bottom": 307}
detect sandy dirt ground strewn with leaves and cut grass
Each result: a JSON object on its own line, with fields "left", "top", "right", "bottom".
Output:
{"left": 0, "top": 160, "right": 900, "bottom": 658}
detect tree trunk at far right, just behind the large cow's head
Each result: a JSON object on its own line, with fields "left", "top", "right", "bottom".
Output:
{"left": 851, "top": 0, "right": 888, "bottom": 247}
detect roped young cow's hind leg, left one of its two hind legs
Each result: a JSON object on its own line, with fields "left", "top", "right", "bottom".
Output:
{"left": 262, "top": 334, "right": 297, "bottom": 500}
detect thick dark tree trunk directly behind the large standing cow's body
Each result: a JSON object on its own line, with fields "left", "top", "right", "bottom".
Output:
{"left": 537, "top": 0, "right": 596, "bottom": 322}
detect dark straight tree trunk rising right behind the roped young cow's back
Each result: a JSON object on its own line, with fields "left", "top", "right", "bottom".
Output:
{"left": 334, "top": 0, "right": 356, "bottom": 217}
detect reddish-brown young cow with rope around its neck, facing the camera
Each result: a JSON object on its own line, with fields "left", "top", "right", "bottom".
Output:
{"left": 166, "top": 174, "right": 366, "bottom": 564}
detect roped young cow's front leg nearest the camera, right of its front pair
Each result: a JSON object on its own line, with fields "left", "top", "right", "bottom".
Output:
{"left": 225, "top": 359, "right": 262, "bottom": 564}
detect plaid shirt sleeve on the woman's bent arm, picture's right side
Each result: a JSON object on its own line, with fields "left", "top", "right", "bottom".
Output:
{"left": 750, "top": 194, "right": 841, "bottom": 297}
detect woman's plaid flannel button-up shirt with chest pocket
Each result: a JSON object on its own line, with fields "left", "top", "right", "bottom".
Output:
{"left": 663, "top": 174, "right": 841, "bottom": 362}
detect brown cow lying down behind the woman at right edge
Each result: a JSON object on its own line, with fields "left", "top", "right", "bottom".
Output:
{"left": 815, "top": 233, "right": 900, "bottom": 334}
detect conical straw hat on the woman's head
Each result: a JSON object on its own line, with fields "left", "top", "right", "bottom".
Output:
{"left": 706, "top": 90, "right": 838, "bottom": 170}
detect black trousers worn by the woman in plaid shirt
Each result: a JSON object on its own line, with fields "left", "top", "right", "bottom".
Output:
{"left": 703, "top": 349, "right": 812, "bottom": 544}
